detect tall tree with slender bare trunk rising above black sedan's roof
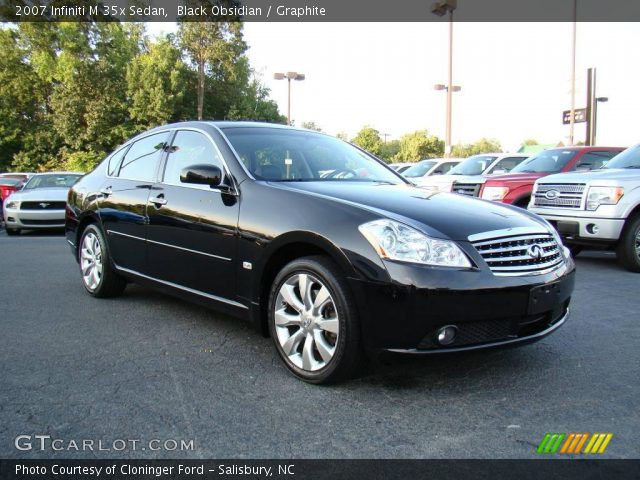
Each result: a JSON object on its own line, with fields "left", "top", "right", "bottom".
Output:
{"left": 178, "top": 21, "right": 247, "bottom": 120}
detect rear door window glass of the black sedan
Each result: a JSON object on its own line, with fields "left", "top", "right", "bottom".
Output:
{"left": 119, "top": 132, "right": 168, "bottom": 182}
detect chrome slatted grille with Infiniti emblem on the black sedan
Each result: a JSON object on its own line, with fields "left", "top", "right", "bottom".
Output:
{"left": 472, "top": 233, "right": 564, "bottom": 276}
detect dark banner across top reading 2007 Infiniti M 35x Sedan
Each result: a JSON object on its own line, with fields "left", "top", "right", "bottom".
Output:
{"left": 0, "top": 0, "right": 640, "bottom": 22}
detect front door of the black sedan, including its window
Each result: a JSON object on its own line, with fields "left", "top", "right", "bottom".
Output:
{"left": 147, "top": 129, "right": 239, "bottom": 303}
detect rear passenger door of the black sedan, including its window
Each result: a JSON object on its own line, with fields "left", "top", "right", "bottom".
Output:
{"left": 100, "top": 131, "right": 169, "bottom": 274}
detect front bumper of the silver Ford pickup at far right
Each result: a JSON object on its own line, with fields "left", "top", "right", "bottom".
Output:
{"left": 530, "top": 208, "right": 624, "bottom": 243}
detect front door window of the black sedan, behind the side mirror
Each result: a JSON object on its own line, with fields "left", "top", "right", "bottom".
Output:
{"left": 164, "top": 130, "right": 223, "bottom": 185}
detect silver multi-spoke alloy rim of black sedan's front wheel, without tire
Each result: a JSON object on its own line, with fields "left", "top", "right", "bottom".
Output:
{"left": 274, "top": 273, "right": 339, "bottom": 372}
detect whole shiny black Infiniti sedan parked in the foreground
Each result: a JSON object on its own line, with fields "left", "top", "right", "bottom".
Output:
{"left": 66, "top": 122, "right": 575, "bottom": 383}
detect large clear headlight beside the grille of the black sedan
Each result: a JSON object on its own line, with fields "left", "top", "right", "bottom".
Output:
{"left": 358, "top": 220, "right": 471, "bottom": 268}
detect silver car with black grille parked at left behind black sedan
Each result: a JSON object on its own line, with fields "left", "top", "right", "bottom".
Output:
{"left": 3, "top": 172, "right": 84, "bottom": 235}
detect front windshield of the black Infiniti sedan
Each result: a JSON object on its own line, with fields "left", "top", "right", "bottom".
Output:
{"left": 224, "top": 127, "right": 405, "bottom": 184}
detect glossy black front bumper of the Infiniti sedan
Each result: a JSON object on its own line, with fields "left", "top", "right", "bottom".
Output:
{"left": 351, "top": 260, "right": 575, "bottom": 353}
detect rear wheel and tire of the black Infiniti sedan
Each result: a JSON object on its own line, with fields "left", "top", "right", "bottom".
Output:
{"left": 78, "top": 224, "right": 126, "bottom": 298}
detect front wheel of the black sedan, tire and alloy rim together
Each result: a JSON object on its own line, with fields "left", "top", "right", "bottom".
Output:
{"left": 268, "top": 256, "right": 362, "bottom": 384}
